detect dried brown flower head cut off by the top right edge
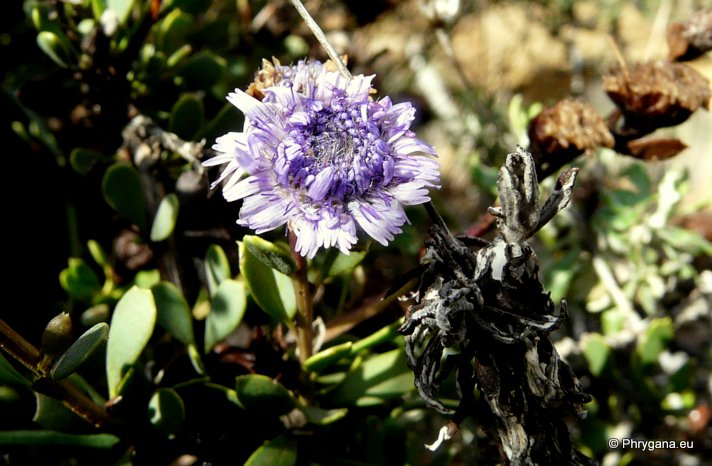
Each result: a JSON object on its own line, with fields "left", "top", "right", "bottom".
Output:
{"left": 667, "top": 8, "right": 712, "bottom": 61}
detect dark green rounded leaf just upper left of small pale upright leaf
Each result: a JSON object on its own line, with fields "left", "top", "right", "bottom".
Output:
{"left": 101, "top": 162, "right": 146, "bottom": 230}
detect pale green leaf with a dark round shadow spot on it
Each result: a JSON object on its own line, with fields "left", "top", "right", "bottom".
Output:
{"left": 205, "top": 279, "right": 247, "bottom": 353}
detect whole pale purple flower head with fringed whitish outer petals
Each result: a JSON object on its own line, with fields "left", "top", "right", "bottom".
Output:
{"left": 205, "top": 61, "right": 439, "bottom": 258}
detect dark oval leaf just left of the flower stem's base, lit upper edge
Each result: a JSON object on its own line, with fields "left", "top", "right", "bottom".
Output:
{"left": 235, "top": 374, "right": 297, "bottom": 417}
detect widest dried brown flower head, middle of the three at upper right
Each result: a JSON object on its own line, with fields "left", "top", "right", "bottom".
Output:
{"left": 603, "top": 61, "right": 710, "bottom": 131}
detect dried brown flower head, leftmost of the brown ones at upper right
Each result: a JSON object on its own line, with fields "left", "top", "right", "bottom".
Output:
{"left": 528, "top": 99, "right": 614, "bottom": 175}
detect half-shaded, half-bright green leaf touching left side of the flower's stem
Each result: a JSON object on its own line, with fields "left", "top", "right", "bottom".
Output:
{"left": 238, "top": 243, "right": 297, "bottom": 325}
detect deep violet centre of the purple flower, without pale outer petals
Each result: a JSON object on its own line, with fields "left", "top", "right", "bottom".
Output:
{"left": 275, "top": 97, "right": 394, "bottom": 202}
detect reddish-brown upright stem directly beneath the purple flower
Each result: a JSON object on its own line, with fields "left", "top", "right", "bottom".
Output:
{"left": 289, "top": 230, "right": 314, "bottom": 363}
